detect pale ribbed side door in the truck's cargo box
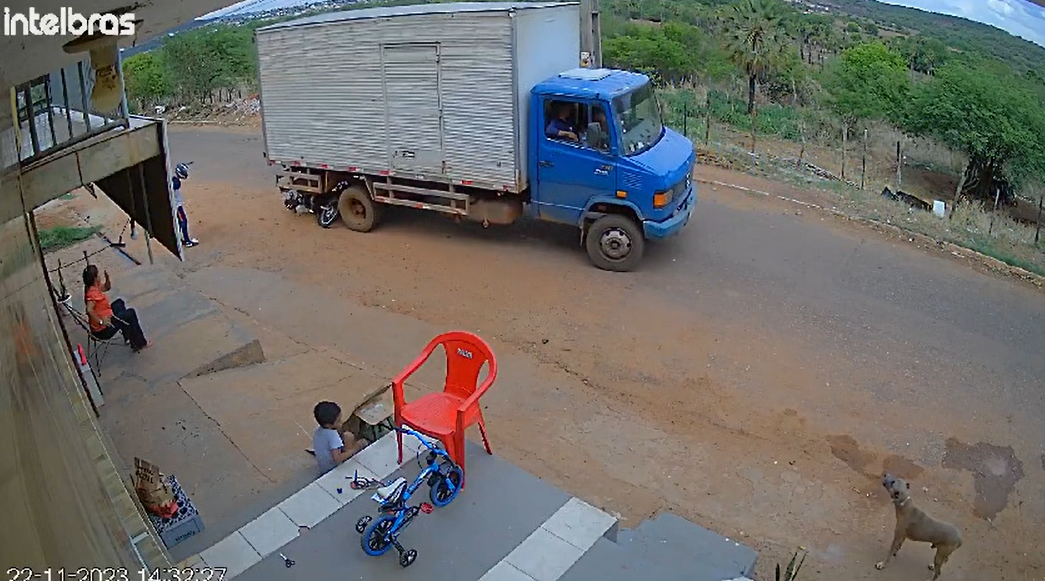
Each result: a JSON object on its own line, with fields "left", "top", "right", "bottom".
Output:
{"left": 381, "top": 43, "right": 443, "bottom": 175}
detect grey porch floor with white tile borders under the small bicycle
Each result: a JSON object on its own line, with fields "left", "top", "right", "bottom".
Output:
{"left": 201, "top": 434, "right": 617, "bottom": 581}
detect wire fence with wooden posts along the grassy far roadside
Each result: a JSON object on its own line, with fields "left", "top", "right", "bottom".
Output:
{"left": 660, "top": 87, "right": 1045, "bottom": 274}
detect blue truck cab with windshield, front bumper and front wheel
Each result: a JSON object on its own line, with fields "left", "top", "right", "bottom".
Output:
{"left": 528, "top": 69, "right": 697, "bottom": 271}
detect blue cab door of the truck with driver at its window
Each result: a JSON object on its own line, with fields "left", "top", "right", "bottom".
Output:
{"left": 535, "top": 97, "right": 617, "bottom": 225}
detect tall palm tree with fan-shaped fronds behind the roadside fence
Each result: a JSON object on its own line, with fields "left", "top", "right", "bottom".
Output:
{"left": 724, "top": 0, "right": 787, "bottom": 114}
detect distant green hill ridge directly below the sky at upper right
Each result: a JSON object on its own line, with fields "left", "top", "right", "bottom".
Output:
{"left": 814, "top": 0, "right": 1045, "bottom": 76}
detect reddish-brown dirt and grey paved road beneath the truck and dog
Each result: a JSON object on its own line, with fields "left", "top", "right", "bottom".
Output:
{"left": 158, "top": 129, "right": 1045, "bottom": 580}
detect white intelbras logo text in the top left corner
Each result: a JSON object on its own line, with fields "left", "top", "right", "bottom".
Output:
{"left": 3, "top": 7, "right": 135, "bottom": 37}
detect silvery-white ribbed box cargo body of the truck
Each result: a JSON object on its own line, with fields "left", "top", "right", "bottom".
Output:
{"left": 256, "top": 2, "right": 580, "bottom": 192}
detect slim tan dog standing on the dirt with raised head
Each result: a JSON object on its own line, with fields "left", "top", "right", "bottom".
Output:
{"left": 875, "top": 473, "right": 961, "bottom": 581}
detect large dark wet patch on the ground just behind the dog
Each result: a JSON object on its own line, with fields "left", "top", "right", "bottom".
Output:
{"left": 943, "top": 438, "right": 1023, "bottom": 519}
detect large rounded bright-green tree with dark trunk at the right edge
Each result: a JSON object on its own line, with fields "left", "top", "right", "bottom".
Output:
{"left": 904, "top": 61, "right": 1045, "bottom": 203}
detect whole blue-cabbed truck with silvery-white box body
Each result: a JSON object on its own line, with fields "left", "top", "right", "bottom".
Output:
{"left": 255, "top": 2, "right": 697, "bottom": 272}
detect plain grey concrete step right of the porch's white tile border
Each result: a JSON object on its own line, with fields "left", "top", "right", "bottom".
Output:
{"left": 561, "top": 513, "right": 758, "bottom": 581}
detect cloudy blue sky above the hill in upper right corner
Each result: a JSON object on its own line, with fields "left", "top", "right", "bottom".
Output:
{"left": 885, "top": 0, "right": 1045, "bottom": 46}
